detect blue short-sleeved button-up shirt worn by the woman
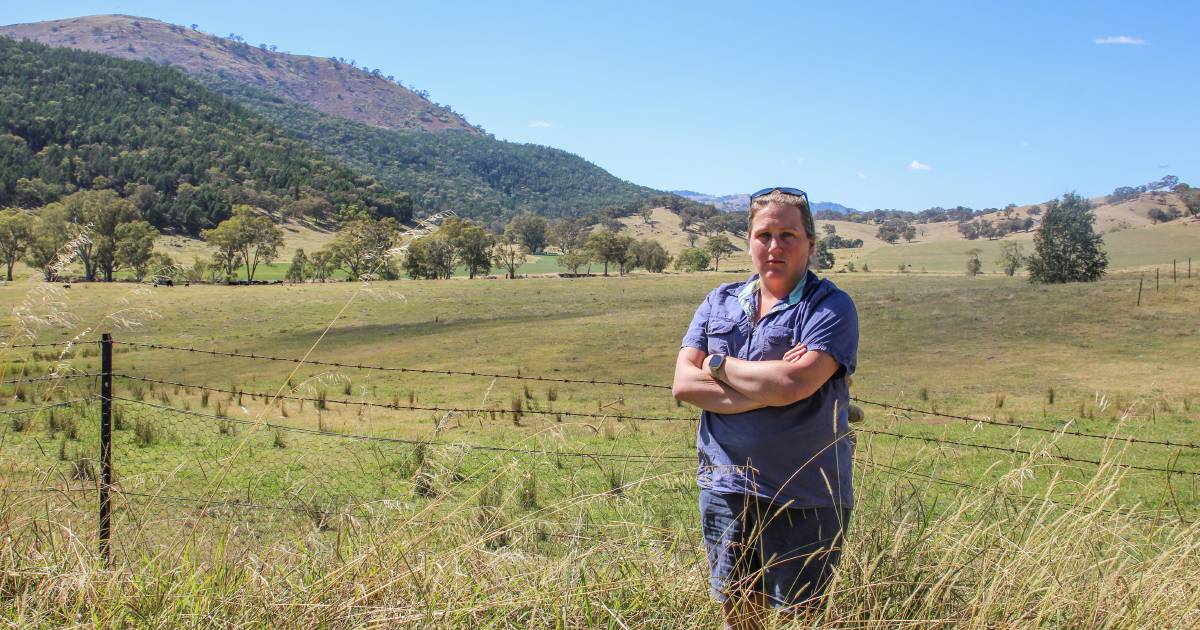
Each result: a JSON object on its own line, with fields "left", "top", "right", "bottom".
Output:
{"left": 683, "top": 271, "right": 858, "bottom": 508}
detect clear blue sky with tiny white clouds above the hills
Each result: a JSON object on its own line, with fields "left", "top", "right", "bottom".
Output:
{"left": 0, "top": 0, "right": 1200, "bottom": 210}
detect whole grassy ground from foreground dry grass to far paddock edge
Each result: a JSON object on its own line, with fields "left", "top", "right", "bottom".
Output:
{"left": 0, "top": 274, "right": 1200, "bottom": 628}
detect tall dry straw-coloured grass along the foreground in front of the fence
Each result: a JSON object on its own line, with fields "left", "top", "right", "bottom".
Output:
{"left": 0, "top": 441, "right": 1200, "bottom": 628}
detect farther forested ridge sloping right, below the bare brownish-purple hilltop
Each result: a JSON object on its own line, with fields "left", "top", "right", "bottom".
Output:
{"left": 208, "top": 80, "right": 660, "bottom": 220}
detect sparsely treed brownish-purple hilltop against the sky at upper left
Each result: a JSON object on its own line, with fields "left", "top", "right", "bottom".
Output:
{"left": 0, "top": 16, "right": 479, "bottom": 133}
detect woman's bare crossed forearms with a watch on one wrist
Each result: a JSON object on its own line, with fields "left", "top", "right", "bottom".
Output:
{"left": 671, "top": 344, "right": 838, "bottom": 414}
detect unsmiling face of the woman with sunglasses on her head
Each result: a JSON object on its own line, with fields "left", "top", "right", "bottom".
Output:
{"left": 750, "top": 202, "right": 816, "bottom": 294}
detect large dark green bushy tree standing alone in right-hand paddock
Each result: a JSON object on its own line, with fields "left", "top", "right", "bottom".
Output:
{"left": 1028, "top": 192, "right": 1109, "bottom": 283}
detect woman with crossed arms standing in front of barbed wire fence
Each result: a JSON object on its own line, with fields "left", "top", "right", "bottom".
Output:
{"left": 672, "top": 187, "right": 858, "bottom": 628}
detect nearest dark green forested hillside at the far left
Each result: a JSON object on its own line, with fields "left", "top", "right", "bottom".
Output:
{"left": 0, "top": 37, "right": 413, "bottom": 234}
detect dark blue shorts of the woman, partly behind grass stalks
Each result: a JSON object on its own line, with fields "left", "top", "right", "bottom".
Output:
{"left": 700, "top": 488, "right": 850, "bottom": 607}
